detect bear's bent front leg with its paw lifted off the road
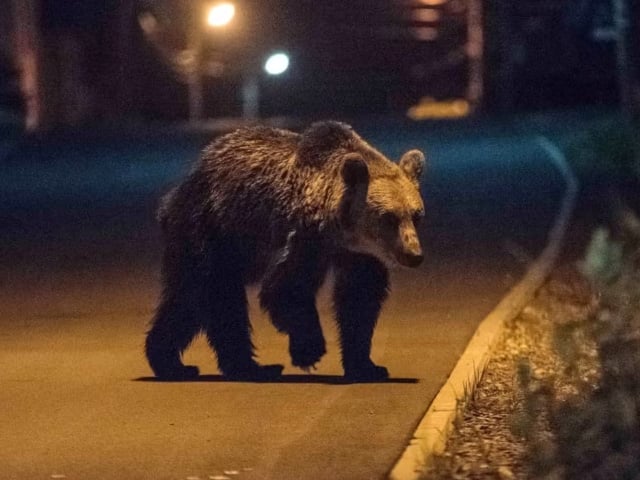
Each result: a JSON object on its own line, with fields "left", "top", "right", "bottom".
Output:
{"left": 260, "top": 231, "right": 327, "bottom": 370}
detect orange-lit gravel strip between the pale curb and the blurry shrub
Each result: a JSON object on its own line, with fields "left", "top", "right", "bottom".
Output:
{"left": 424, "top": 264, "right": 598, "bottom": 480}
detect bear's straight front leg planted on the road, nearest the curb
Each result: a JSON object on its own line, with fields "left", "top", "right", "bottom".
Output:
{"left": 333, "top": 252, "right": 389, "bottom": 382}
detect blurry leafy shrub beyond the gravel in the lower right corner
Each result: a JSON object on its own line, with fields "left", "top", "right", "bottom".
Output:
{"left": 521, "top": 229, "right": 640, "bottom": 479}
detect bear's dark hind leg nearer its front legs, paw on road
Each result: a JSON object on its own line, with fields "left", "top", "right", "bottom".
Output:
{"left": 199, "top": 272, "right": 284, "bottom": 381}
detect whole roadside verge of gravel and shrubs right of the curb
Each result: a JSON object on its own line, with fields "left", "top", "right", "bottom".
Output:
{"left": 425, "top": 118, "right": 640, "bottom": 480}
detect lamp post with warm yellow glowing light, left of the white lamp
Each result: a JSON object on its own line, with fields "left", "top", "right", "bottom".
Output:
{"left": 186, "top": 2, "right": 236, "bottom": 122}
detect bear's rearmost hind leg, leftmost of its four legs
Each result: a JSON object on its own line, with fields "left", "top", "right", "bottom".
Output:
{"left": 145, "top": 290, "right": 200, "bottom": 380}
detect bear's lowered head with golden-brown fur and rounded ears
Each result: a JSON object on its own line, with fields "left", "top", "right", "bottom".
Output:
{"left": 339, "top": 146, "right": 425, "bottom": 267}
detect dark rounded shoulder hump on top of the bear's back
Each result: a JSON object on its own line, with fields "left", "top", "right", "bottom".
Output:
{"left": 298, "top": 121, "right": 353, "bottom": 167}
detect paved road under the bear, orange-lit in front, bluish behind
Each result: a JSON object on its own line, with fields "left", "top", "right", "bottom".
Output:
{"left": 0, "top": 120, "right": 563, "bottom": 479}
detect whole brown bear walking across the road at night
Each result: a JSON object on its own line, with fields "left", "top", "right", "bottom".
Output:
{"left": 146, "top": 122, "right": 425, "bottom": 382}
